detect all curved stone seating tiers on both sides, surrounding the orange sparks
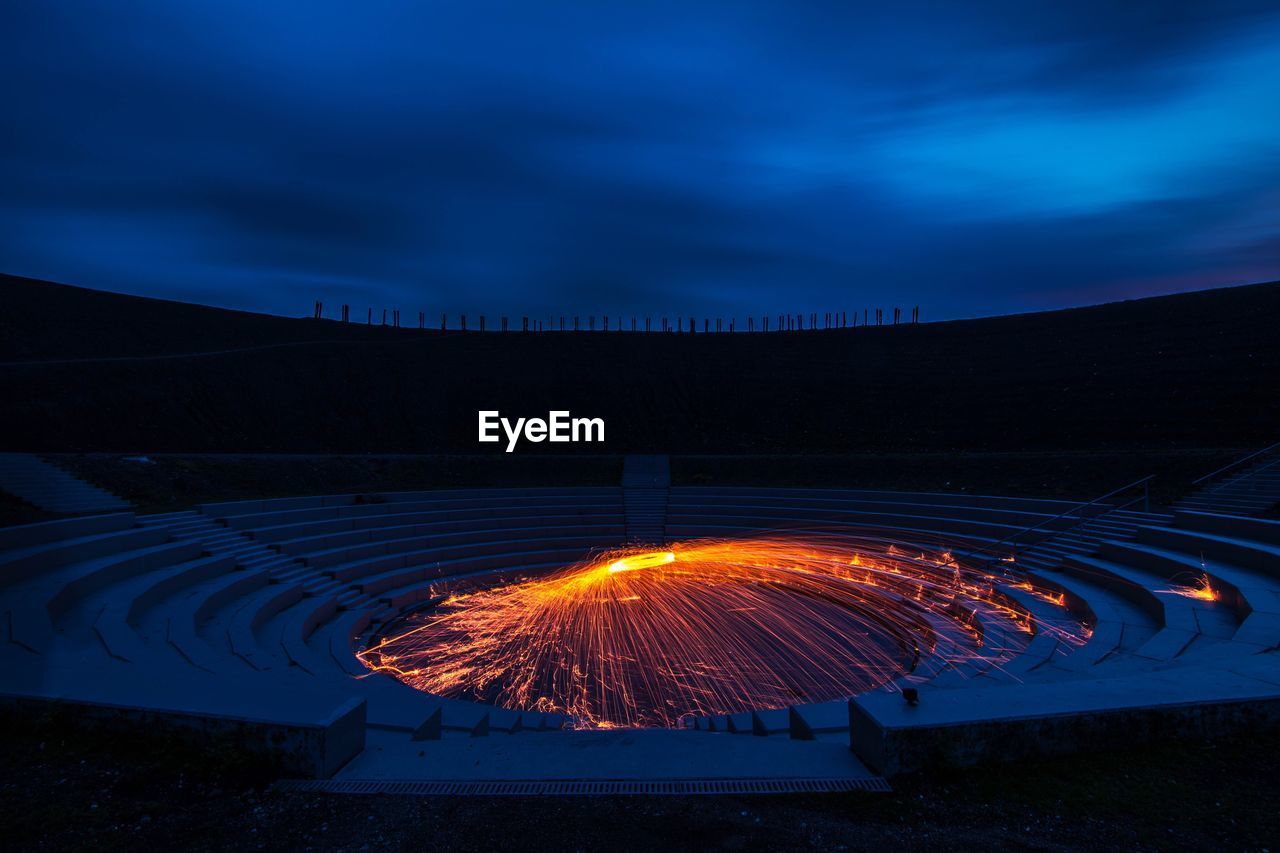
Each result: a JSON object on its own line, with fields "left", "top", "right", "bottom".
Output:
{"left": 0, "top": 487, "right": 1280, "bottom": 768}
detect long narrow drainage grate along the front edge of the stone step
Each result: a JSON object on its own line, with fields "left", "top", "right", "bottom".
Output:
{"left": 274, "top": 776, "right": 892, "bottom": 797}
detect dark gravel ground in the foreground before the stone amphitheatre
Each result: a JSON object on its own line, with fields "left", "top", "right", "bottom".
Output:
{"left": 0, "top": 717, "right": 1280, "bottom": 850}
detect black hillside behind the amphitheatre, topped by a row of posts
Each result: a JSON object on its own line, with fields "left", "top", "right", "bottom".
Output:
{"left": 0, "top": 278, "right": 1280, "bottom": 453}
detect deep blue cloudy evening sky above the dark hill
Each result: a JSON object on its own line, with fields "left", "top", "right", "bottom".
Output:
{"left": 0, "top": 0, "right": 1280, "bottom": 319}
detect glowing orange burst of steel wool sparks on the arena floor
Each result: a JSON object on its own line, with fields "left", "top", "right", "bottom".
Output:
{"left": 361, "top": 538, "right": 1080, "bottom": 727}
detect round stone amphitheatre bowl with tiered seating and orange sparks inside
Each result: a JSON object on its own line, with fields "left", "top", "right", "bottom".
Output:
{"left": 0, "top": 487, "right": 1280, "bottom": 793}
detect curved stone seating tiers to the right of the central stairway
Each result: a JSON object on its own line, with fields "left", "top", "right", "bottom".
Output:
{"left": 667, "top": 487, "right": 1280, "bottom": 735}
